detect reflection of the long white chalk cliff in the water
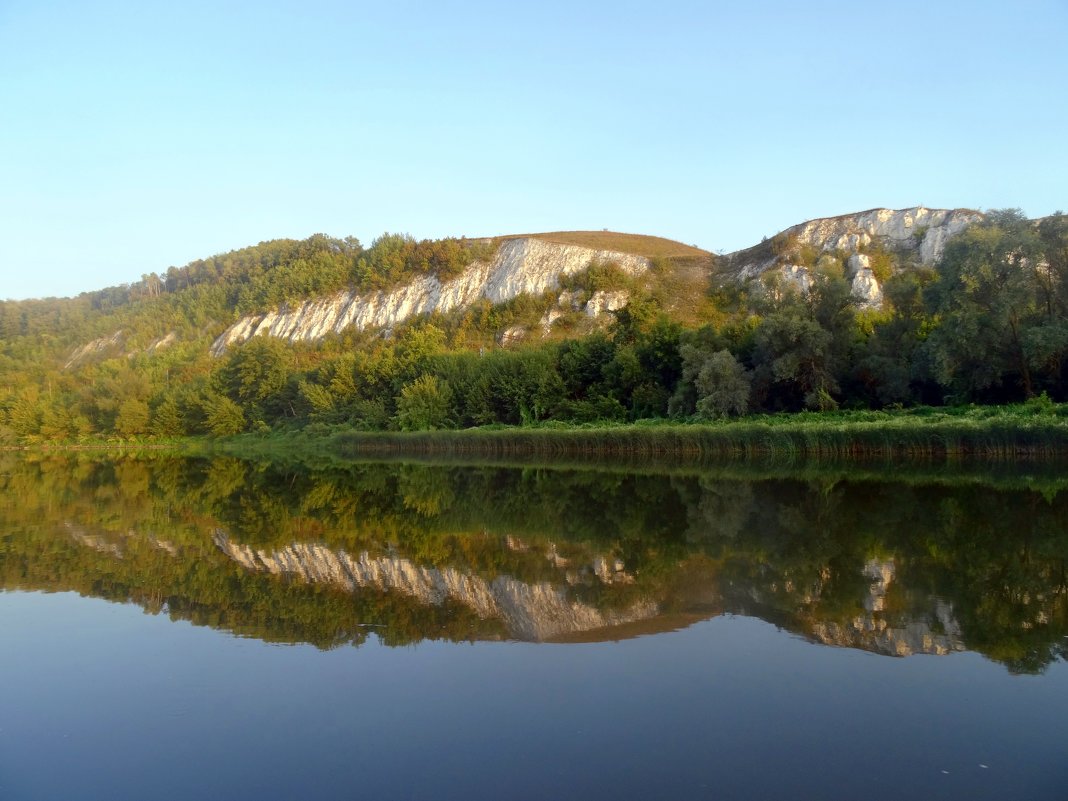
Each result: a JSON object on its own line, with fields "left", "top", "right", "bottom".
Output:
{"left": 214, "top": 530, "right": 659, "bottom": 641}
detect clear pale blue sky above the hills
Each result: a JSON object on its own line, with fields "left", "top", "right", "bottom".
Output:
{"left": 0, "top": 0, "right": 1068, "bottom": 298}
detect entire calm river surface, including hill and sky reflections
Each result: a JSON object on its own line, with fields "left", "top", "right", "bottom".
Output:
{"left": 0, "top": 456, "right": 1068, "bottom": 800}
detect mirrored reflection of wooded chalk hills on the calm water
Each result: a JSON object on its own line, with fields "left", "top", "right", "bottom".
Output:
{"left": 0, "top": 454, "right": 1068, "bottom": 672}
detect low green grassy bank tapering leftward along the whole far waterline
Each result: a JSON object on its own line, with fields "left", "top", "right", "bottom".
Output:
{"left": 12, "top": 401, "right": 1068, "bottom": 466}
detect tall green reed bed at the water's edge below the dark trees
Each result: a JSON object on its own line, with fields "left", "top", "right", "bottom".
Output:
{"left": 334, "top": 413, "right": 1068, "bottom": 461}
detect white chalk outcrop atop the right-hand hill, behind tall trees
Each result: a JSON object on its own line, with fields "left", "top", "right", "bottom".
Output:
{"left": 723, "top": 206, "right": 983, "bottom": 309}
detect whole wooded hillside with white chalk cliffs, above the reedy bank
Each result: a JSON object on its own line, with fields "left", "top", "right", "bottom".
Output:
{"left": 0, "top": 207, "right": 1068, "bottom": 442}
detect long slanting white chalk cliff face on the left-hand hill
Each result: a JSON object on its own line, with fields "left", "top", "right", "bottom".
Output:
{"left": 211, "top": 237, "right": 649, "bottom": 356}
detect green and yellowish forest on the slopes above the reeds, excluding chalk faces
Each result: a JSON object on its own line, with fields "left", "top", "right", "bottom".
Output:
{"left": 0, "top": 209, "right": 1068, "bottom": 445}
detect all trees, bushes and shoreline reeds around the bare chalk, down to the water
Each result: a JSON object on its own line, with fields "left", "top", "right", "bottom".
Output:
{"left": 6, "top": 209, "right": 1068, "bottom": 454}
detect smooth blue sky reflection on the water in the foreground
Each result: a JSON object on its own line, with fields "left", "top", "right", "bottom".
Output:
{"left": 0, "top": 593, "right": 1068, "bottom": 801}
